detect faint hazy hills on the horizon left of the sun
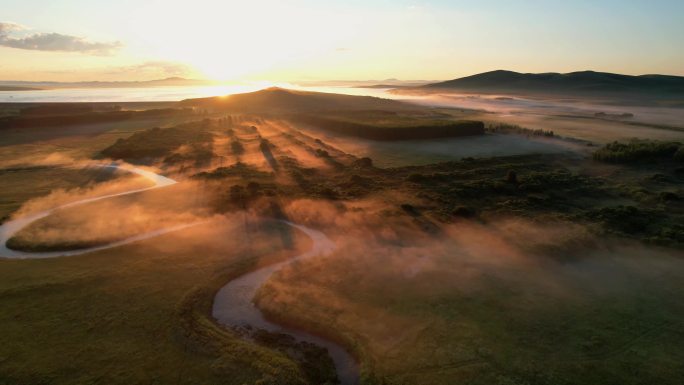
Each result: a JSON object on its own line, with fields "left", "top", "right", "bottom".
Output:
{"left": 0, "top": 77, "right": 217, "bottom": 91}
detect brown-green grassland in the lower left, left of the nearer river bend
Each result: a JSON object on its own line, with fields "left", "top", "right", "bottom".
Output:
{"left": 0, "top": 218, "right": 336, "bottom": 384}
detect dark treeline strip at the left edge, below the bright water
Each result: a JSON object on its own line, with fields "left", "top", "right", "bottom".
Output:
{"left": 0, "top": 108, "right": 193, "bottom": 129}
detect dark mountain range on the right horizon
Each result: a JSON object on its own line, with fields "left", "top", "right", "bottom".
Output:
{"left": 413, "top": 70, "right": 684, "bottom": 95}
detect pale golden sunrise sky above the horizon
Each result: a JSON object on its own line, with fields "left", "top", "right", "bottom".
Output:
{"left": 0, "top": 0, "right": 684, "bottom": 82}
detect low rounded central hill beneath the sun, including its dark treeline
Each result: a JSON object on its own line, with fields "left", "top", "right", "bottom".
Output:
{"left": 180, "top": 87, "right": 484, "bottom": 140}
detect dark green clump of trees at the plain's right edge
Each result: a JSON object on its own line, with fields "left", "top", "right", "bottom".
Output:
{"left": 594, "top": 139, "right": 684, "bottom": 163}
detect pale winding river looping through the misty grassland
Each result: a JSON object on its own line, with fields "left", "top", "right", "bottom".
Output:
{"left": 0, "top": 163, "right": 359, "bottom": 385}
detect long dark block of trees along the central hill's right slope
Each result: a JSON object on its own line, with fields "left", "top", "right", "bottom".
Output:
{"left": 290, "top": 115, "right": 485, "bottom": 141}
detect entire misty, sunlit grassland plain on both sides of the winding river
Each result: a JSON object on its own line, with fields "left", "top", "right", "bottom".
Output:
{"left": 0, "top": 97, "right": 684, "bottom": 385}
